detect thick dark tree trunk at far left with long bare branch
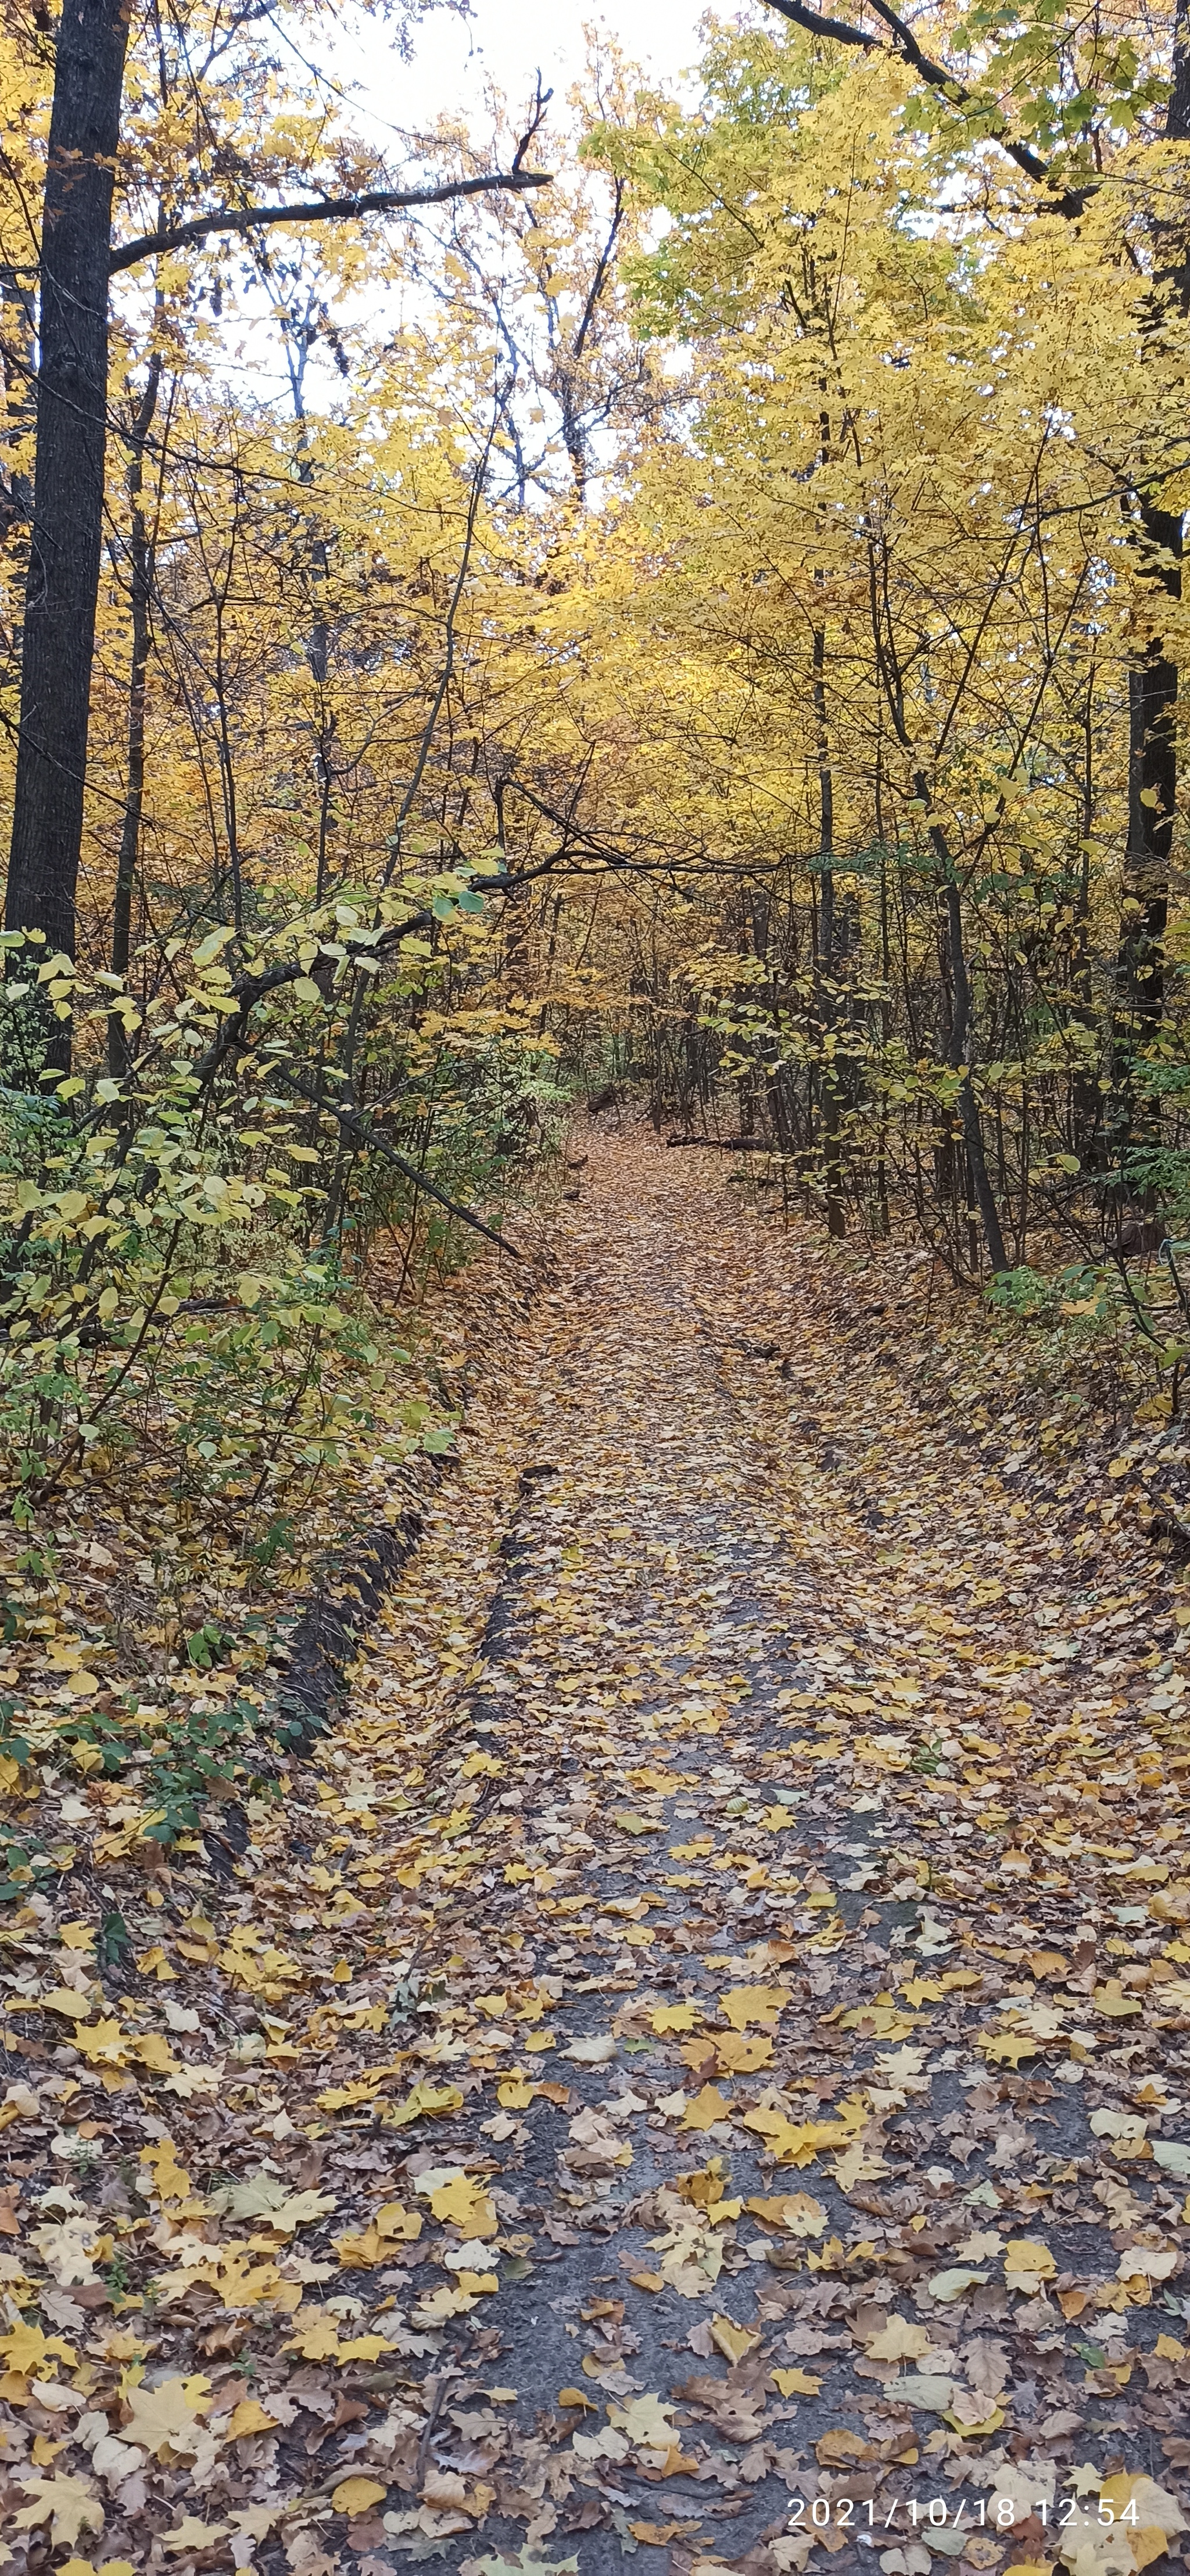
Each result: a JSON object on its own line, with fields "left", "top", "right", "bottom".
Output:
{"left": 5, "top": 0, "right": 129, "bottom": 1036}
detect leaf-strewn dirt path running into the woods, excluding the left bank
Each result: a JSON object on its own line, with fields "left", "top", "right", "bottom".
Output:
{"left": 304, "top": 1134, "right": 1190, "bottom": 2576}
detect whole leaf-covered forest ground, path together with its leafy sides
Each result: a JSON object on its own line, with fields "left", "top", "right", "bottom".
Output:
{"left": 0, "top": 1128, "right": 1190, "bottom": 2576}
